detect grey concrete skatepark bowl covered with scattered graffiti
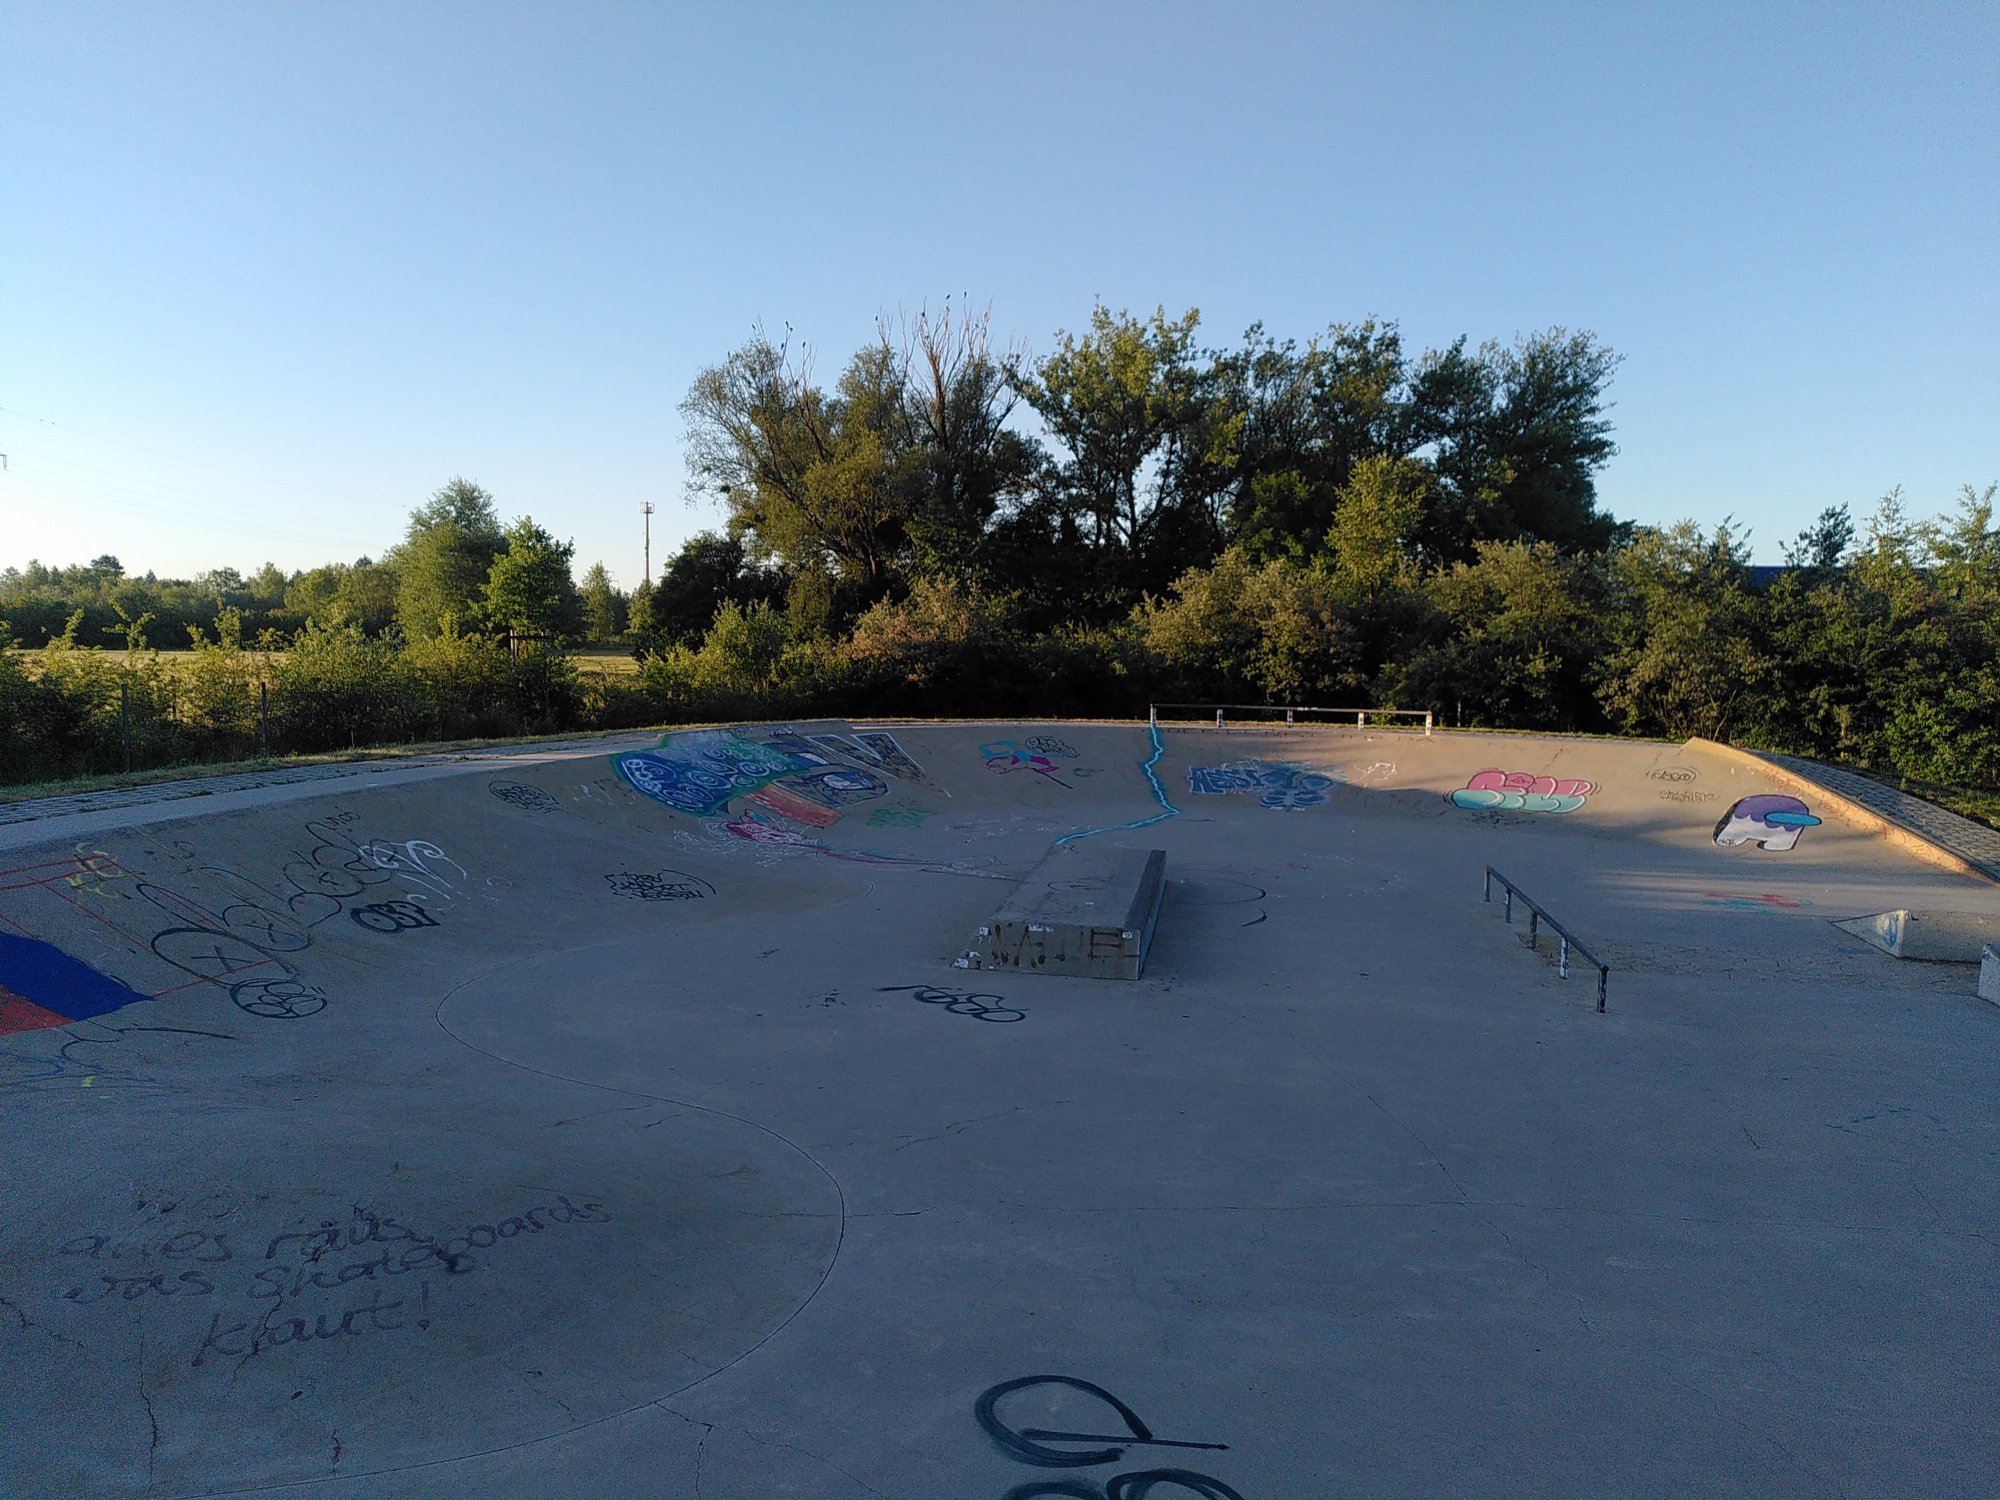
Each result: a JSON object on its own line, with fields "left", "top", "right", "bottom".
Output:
{"left": 0, "top": 722, "right": 2000, "bottom": 1500}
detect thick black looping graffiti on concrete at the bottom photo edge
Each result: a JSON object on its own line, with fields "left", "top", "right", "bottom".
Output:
{"left": 972, "top": 1376, "right": 1244, "bottom": 1500}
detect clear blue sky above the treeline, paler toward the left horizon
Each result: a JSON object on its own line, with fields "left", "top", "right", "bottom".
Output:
{"left": 0, "top": 0, "right": 2000, "bottom": 586}
